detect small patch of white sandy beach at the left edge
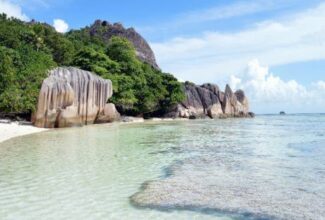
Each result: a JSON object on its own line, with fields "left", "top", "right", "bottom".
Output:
{"left": 0, "top": 122, "right": 47, "bottom": 143}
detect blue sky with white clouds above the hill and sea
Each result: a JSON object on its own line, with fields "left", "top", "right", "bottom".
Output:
{"left": 0, "top": 0, "right": 325, "bottom": 113}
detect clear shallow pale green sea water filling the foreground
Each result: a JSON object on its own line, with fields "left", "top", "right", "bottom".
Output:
{"left": 0, "top": 115, "right": 325, "bottom": 220}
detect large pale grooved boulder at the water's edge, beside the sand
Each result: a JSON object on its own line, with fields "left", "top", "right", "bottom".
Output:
{"left": 33, "top": 67, "right": 119, "bottom": 128}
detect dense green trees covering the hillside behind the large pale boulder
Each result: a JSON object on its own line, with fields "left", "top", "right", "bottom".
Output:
{"left": 0, "top": 14, "right": 184, "bottom": 115}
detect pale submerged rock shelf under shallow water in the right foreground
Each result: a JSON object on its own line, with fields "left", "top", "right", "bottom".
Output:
{"left": 130, "top": 155, "right": 325, "bottom": 220}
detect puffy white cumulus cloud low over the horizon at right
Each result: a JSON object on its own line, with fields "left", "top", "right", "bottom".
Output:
{"left": 229, "top": 59, "right": 325, "bottom": 113}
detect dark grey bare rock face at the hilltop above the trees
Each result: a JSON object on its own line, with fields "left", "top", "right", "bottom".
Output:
{"left": 88, "top": 20, "right": 159, "bottom": 69}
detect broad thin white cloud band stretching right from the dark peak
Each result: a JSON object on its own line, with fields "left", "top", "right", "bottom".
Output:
{"left": 151, "top": 3, "right": 325, "bottom": 83}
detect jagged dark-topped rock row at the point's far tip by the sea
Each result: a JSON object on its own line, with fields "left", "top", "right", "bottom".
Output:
{"left": 166, "top": 82, "right": 254, "bottom": 118}
